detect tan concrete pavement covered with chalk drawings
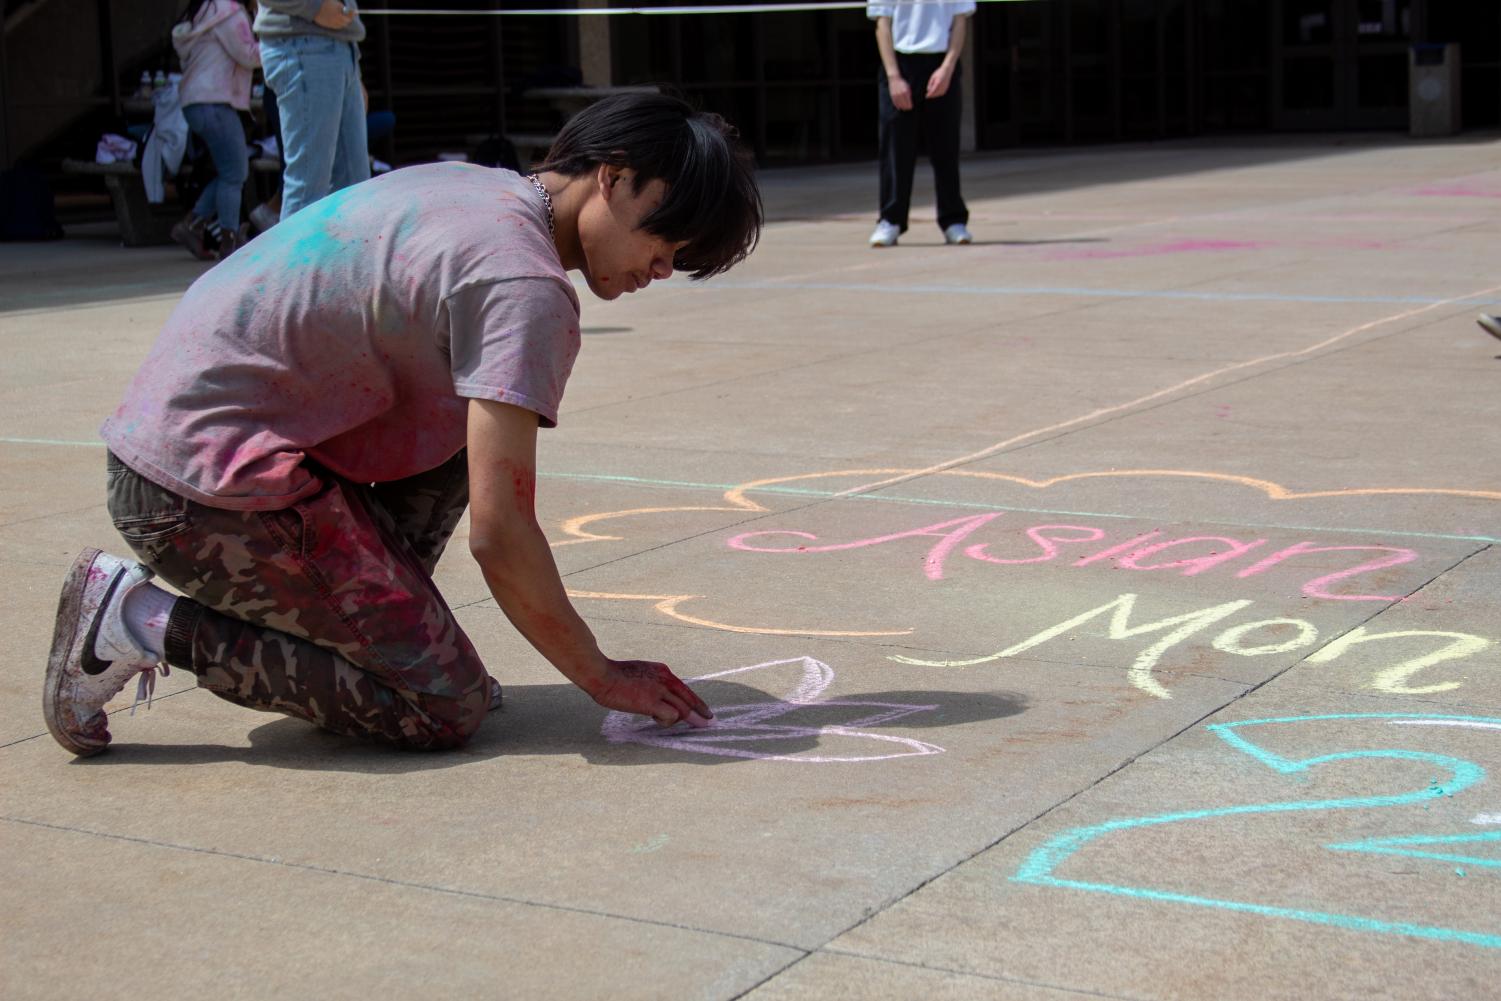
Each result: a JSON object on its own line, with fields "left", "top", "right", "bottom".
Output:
{"left": 0, "top": 137, "right": 1501, "bottom": 1001}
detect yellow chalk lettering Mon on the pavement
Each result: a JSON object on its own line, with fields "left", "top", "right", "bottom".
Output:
{"left": 890, "top": 594, "right": 1495, "bottom": 699}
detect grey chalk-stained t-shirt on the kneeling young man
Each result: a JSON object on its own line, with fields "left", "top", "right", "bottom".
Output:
{"left": 101, "top": 164, "right": 579, "bottom": 510}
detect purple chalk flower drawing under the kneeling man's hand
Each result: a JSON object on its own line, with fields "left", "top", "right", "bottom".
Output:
{"left": 600, "top": 657, "right": 944, "bottom": 762}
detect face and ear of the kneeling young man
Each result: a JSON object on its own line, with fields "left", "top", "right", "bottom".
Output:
{"left": 578, "top": 165, "right": 687, "bottom": 299}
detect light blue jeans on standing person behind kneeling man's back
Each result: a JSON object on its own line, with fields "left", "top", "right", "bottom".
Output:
{"left": 261, "top": 35, "right": 371, "bottom": 219}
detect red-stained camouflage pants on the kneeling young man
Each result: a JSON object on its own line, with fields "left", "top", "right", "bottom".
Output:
{"left": 108, "top": 452, "right": 489, "bottom": 749}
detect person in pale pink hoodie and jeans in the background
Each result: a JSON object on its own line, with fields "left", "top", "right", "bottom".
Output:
{"left": 171, "top": 0, "right": 261, "bottom": 261}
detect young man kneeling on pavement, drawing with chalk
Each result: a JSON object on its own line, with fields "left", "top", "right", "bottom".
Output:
{"left": 44, "top": 95, "right": 761, "bottom": 755}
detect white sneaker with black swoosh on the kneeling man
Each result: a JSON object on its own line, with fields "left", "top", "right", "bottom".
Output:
{"left": 42, "top": 549, "right": 167, "bottom": 758}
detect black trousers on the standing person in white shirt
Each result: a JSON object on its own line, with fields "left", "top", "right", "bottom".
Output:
{"left": 877, "top": 53, "right": 970, "bottom": 233}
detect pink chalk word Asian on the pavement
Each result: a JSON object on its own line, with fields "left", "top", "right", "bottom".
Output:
{"left": 728, "top": 510, "right": 1418, "bottom": 602}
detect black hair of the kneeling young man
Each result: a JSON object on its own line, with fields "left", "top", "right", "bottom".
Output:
{"left": 537, "top": 93, "right": 763, "bottom": 279}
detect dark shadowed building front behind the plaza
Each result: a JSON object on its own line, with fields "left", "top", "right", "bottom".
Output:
{"left": 0, "top": 0, "right": 1501, "bottom": 164}
